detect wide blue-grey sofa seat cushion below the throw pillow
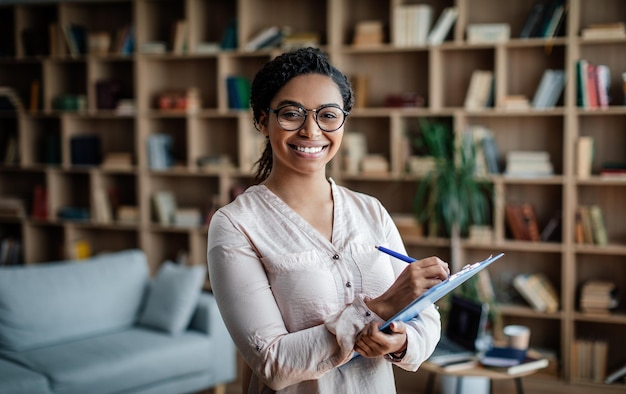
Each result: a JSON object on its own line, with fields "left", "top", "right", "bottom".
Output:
{"left": 2, "top": 327, "right": 213, "bottom": 394}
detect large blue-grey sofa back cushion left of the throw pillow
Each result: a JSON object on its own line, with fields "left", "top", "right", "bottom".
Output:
{"left": 0, "top": 250, "right": 149, "bottom": 350}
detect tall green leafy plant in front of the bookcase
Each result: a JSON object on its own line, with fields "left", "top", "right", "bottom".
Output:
{"left": 414, "top": 118, "right": 500, "bottom": 328}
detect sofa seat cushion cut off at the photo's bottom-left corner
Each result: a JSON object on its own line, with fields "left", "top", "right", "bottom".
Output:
{"left": 0, "top": 358, "right": 50, "bottom": 394}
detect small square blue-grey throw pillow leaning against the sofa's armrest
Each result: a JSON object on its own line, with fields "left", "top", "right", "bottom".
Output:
{"left": 139, "top": 261, "right": 206, "bottom": 335}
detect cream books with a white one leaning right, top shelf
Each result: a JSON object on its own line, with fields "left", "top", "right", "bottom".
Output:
{"left": 392, "top": 4, "right": 458, "bottom": 46}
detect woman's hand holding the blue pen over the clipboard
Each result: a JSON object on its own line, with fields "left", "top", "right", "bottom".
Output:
{"left": 366, "top": 256, "right": 450, "bottom": 320}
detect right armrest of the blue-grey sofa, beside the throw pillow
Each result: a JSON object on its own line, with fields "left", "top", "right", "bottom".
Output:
{"left": 189, "top": 292, "right": 237, "bottom": 383}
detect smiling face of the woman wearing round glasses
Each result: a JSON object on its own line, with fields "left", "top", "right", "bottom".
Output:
{"left": 259, "top": 74, "right": 344, "bottom": 176}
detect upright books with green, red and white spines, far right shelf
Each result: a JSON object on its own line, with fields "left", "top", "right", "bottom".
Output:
{"left": 576, "top": 59, "right": 611, "bottom": 109}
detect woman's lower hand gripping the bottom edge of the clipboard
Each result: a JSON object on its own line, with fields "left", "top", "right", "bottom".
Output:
{"left": 354, "top": 322, "right": 407, "bottom": 358}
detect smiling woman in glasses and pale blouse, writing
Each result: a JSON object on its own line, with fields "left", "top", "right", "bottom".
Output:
{"left": 207, "top": 48, "right": 449, "bottom": 394}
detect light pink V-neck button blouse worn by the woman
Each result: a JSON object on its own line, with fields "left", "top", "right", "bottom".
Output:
{"left": 207, "top": 179, "right": 441, "bottom": 394}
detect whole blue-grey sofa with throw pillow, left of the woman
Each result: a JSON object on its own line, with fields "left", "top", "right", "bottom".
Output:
{"left": 0, "top": 250, "right": 236, "bottom": 394}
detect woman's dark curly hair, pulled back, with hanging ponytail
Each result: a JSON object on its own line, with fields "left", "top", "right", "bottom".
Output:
{"left": 250, "top": 48, "right": 354, "bottom": 183}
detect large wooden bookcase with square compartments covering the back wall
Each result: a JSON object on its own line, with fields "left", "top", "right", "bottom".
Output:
{"left": 0, "top": 0, "right": 626, "bottom": 390}
